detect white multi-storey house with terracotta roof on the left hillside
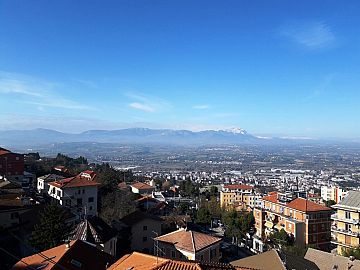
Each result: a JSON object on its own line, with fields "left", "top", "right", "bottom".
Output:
{"left": 48, "top": 171, "right": 99, "bottom": 216}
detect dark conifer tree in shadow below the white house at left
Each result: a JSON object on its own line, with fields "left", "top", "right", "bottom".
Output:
{"left": 30, "top": 204, "right": 71, "bottom": 250}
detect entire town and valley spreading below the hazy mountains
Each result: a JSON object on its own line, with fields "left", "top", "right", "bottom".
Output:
{"left": 0, "top": 135, "right": 360, "bottom": 269}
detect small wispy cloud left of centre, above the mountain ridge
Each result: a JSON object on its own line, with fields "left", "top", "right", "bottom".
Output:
{"left": 125, "top": 93, "right": 171, "bottom": 113}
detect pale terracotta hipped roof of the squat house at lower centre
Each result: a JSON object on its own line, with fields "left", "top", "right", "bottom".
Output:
{"left": 155, "top": 229, "right": 221, "bottom": 253}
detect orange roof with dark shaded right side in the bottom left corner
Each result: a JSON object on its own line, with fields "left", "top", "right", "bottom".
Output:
{"left": 12, "top": 240, "right": 114, "bottom": 270}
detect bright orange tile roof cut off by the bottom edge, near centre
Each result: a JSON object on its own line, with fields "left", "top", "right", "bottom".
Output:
{"left": 108, "top": 252, "right": 251, "bottom": 270}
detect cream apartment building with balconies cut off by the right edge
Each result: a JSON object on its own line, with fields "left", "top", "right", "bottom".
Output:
{"left": 331, "top": 191, "right": 360, "bottom": 255}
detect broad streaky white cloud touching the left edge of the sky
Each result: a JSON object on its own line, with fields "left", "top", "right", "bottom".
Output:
{"left": 0, "top": 71, "right": 91, "bottom": 110}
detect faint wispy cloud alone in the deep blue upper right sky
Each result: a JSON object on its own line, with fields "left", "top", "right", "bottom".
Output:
{"left": 279, "top": 21, "right": 336, "bottom": 49}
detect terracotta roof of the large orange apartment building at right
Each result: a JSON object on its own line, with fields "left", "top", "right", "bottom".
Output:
{"left": 262, "top": 192, "right": 331, "bottom": 212}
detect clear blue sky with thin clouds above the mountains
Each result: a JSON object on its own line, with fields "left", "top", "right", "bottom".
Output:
{"left": 0, "top": 0, "right": 360, "bottom": 138}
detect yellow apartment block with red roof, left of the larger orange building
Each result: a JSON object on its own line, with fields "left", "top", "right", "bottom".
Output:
{"left": 220, "top": 185, "right": 261, "bottom": 209}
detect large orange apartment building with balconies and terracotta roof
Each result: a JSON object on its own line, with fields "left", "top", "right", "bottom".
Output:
{"left": 254, "top": 192, "right": 332, "bottom": 251}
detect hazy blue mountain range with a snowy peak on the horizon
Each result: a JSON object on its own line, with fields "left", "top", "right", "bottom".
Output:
{"left": 0, "top": 128, "right": 264, "bottom": 145}
